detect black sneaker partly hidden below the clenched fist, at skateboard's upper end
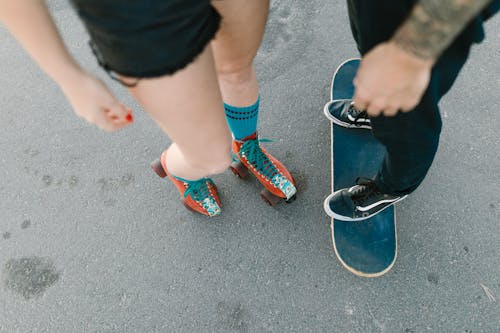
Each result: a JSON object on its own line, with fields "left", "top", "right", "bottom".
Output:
{"left": 323, "top": 99, "right": 372, "bottom": 129}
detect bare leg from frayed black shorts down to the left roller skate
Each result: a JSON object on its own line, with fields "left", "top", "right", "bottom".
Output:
{"left": 129, "top": 46, "right": 231, "bottom": 180}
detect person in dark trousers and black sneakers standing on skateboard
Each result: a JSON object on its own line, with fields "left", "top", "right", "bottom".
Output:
{"left": 325, "top": 0, "right": 500, "bottom": 221}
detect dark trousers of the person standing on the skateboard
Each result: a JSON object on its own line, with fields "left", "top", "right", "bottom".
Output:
{"left": 348, "top": 0, "right": 482, "bottom": 195}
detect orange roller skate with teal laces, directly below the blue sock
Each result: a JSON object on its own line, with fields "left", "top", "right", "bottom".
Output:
{"left": 230, "top": 132, "right": 297, "bottom": 206}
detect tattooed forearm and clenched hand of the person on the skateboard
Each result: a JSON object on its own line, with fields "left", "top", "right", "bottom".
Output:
{"left": 354, "top": 0, "right": 491, "bottom": 116}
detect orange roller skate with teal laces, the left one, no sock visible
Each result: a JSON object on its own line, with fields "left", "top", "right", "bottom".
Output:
{"left": 151, "top": 150, "right": 221, "bottom": 216}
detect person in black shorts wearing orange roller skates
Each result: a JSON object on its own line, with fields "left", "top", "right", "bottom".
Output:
{"left": 0, "top": 0, "right": 296, "bottom": 216}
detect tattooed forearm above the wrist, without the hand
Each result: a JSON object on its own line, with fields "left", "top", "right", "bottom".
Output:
{"left": 393, "top": 0, "right": 491, "bottom": 59}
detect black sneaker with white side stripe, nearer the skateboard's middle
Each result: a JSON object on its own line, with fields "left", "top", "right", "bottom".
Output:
{"left": 323, "top": 177, "right": 407, "bottom": 221}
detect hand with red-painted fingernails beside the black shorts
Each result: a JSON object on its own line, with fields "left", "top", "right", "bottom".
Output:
{"left": 60, "top": 71, "right": 133, "bottom": 132}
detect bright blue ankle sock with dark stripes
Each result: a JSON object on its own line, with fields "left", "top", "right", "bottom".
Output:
{"left": 224, "top": 97, "right": 260, "bottom": 140}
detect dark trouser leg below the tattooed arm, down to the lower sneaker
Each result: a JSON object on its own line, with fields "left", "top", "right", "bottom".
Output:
{"left": 371, "top": 40, "right": 471, "bottom": 195}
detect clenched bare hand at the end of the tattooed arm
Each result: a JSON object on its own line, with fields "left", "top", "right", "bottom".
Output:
{"left": 354, "top": 42, "right": 434, "bottom": 117}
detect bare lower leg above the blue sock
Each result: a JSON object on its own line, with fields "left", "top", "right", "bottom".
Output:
{"left": 212, "top": 0, "right": 269, "bottom": 106}
